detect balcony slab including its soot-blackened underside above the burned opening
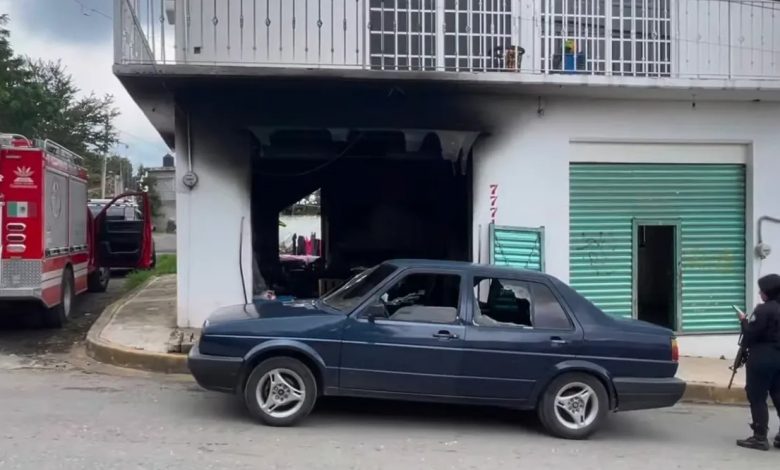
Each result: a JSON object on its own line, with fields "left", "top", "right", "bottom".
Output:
{"left": 114, "top": 64, "right": 780, "bottom": 145}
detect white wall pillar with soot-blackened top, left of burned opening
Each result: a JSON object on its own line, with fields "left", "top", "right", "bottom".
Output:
{"left": 176, "top": 114, "right": 252, "bottom": 327}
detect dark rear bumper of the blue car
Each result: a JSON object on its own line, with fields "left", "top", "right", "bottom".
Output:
{"left": 612, "top": 377, "right": 685, "bottom": 411}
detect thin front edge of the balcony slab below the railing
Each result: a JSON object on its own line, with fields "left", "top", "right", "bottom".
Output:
{"left": 114, "top": 64, "right": 780, "bottom": 101}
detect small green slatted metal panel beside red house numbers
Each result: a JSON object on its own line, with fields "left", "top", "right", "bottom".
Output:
{"left": 490, "top": 225, "right": 544, "bottom": 271}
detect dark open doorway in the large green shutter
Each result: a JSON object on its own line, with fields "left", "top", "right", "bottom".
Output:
{"left": 634, "top": 222, "right": 679, "bottom": 330}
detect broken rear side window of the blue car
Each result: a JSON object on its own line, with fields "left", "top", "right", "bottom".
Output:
{"left": 474, "top": 278, "right": 572, "bottom": 330}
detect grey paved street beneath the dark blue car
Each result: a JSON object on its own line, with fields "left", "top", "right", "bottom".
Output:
{"left": 0, "top": 366, "right": 780, "bottom": 470}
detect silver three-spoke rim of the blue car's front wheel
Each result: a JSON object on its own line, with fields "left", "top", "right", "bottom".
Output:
{"left": 256, "top": 369, "right": 306, "bottom": 419}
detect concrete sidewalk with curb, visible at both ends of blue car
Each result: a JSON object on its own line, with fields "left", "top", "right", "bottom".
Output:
{"left": 87, "top": 275, "right": 746, "bottom": 404}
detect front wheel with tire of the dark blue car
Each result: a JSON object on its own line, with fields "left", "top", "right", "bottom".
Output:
{"left": 244, "top": 357, "right": 317, "bottom": 426}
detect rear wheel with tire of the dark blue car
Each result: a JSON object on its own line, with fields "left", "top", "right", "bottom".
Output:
{"left": 537, "top": 373, "right": 609, "bottom": 439}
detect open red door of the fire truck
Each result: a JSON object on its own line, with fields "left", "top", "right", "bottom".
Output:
{"left": 94, "top": 192, "right": 154, "bottom": 269}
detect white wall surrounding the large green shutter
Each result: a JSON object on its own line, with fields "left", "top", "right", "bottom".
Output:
{"left": 474, "top": 98, "right": 780, "bottom": 357}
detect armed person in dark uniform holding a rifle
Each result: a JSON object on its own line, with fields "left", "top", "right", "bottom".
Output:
{"left": 737, "top": 274, "right": 780, "bottom": 450}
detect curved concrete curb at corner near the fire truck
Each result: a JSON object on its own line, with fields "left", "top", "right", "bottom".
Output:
{"left": 86, "top": 277, "right": 189, "bottom": 374}
